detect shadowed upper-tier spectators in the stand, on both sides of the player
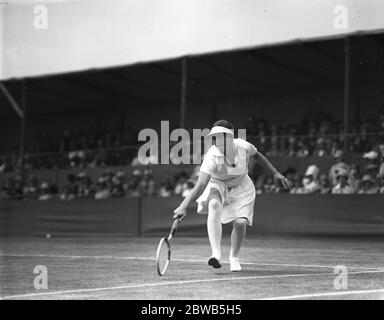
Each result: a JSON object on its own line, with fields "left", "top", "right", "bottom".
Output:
{"left": 0, "top": 112, "right": 384, "bottom": 173}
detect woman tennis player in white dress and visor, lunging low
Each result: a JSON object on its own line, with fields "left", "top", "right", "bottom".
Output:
{"left": 173, "top": 120, "right": 292, "bottom": 271}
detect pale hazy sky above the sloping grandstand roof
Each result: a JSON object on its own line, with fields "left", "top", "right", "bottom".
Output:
{"left": 0, "top": 0, "right": 384, "bottom": 79}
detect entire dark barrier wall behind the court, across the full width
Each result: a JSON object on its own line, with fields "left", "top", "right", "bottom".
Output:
{"left": 0, "top": 195, "right": 384, "bottom": 236}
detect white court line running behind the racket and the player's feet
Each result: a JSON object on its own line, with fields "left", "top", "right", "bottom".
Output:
{"left": 0, "top": 253, "right": 384, "bottom": 270}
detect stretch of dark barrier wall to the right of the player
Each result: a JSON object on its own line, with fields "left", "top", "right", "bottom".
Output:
{"left": 250, "top": 194, "right": 384, "bottom": 235}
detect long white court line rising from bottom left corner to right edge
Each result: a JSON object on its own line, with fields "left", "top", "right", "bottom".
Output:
{"left": 0, "top": 270, "right": 384, "bottom": 300}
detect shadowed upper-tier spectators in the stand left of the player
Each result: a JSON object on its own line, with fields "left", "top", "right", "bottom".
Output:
{"left": 0, "top": 126, "right": 137, "bottom": 173}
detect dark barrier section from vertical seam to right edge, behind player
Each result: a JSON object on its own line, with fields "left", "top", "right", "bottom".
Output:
{"left": 142, "top": 194, "right": 384, "bottom": 235}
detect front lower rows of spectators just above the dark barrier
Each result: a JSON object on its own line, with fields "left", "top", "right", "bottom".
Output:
{"left": 0, "top": 146, "right": 384, "bottom": 200}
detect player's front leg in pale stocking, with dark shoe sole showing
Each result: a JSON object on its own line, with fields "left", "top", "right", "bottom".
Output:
{"left": 207, "top": 197, "right": 222, "bottom": 268}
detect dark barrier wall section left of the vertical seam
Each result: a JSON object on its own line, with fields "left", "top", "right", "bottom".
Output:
{"left": 0, "top": 198, "right": 139, "bottom": 237}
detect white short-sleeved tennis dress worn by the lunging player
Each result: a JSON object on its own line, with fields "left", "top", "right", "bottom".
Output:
{"left": 196, "top": 139, "right": 257, "bottom": 226}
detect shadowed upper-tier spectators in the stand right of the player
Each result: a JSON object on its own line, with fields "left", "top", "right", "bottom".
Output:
{"left": 246, "top": 112, "right": 384, "bottom": 157}
